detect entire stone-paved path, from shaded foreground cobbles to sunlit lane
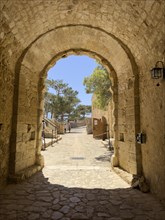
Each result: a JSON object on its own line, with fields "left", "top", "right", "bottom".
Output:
{"left": 0, "top": 128, "right": 165, "bottom": 220}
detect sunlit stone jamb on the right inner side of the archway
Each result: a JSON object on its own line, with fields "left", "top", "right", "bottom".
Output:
{"left": 117, "top": 66, "right": 141, "bottom": 174}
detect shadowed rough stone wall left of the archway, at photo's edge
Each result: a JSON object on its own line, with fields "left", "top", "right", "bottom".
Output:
{"left": 0, "top": 23, "right": 21, "bottom": 187}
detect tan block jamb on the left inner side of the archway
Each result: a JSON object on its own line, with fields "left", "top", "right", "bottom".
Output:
{"left": 15, "top": 66, "right": 38, "bottom": 173}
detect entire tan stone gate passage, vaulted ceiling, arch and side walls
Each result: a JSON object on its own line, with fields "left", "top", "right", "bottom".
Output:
{"left": 0, "top": 0, "right": 165, "bottom": 203}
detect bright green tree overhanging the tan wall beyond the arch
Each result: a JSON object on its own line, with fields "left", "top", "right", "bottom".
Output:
{"left": 83, "top": 65, "right": 112, "bottom": 109}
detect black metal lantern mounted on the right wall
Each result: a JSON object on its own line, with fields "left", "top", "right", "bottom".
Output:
{"left": 151, "top": 61, "right": 165, "bottom": 79}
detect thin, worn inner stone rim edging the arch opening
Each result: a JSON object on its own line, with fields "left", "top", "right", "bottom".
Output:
{"left": 38, "top": 48, "right": 118, "bottom": 155}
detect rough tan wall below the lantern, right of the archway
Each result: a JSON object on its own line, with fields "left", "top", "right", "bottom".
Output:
{"left": 140, "top": 63, "right": 165, "bottom": 199}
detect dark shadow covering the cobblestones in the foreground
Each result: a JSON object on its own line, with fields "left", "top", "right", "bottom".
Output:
{"left": 0, "top": 172, "right": 165, "bottom": 220}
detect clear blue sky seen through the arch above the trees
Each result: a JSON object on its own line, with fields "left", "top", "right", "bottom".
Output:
{"left": 48, "top": 55, "right": 98, "bottom": 105}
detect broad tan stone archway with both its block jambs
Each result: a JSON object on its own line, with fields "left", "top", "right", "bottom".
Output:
{"left": 10, "top": 25, "right": 141, "bottom": 182}
